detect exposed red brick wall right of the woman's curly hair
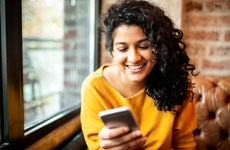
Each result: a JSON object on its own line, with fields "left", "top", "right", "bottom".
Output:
{"left": 182, "top": 0, "right": 230, "bottom": 75}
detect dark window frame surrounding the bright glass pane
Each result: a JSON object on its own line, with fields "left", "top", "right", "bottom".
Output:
{"left": 0, "top": 0, "right": 100, "bottom": 148}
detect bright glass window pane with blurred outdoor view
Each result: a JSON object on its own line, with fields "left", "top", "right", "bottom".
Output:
{"left": 22, "top": 0, "right": 92, "bottom": 128}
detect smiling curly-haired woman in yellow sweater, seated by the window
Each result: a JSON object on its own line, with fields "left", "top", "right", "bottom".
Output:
{"left": 81, "top": 0, "right": 196, "bottom": 150}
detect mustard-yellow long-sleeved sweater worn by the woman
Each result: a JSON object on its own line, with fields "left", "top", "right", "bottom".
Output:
{"left": 81, "top": 65, "right": 196, "bottom": 150}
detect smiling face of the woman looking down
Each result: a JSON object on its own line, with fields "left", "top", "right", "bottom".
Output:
{"left": 112, "top": 25, "right": 156, "bottom": 83}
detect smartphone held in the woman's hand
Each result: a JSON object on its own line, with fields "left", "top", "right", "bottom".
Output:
{"left": 99, "top": 106, "right": 139, "bottom": 130}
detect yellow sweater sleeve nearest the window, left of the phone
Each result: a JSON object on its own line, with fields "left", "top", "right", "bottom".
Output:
{"left": 81, "top": 78, "right": 103, "bottom": 150}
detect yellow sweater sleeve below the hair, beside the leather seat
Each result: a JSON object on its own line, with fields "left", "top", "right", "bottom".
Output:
{"left": 172, "top": 101, "right": 197, "bottom": 149}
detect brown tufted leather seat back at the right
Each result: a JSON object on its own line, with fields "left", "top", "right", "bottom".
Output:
{"left": 192, "top": 76, "right": 230, "bottom": 150}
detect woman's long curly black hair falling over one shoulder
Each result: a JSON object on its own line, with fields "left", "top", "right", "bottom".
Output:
{"left": 103, "top": 0, "right": 196, "bottom": 111}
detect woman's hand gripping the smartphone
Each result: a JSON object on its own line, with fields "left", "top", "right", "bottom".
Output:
{"left": 99, "top": 127, "right": 147, "bottom": 150}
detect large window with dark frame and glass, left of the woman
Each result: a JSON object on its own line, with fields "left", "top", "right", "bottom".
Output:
{"left": 0, "top": 0, "right": 98, "bottom": 148}
